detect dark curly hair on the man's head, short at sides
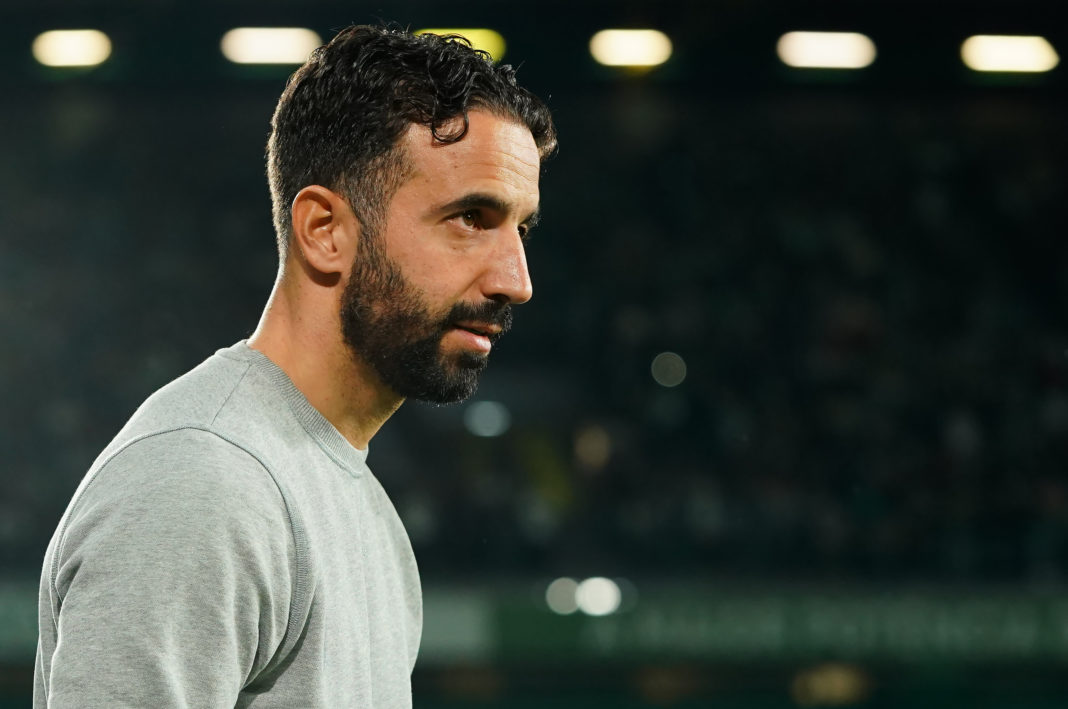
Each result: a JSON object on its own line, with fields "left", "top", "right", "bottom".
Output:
{"left": 267, "top": 26, "right": 556, "bottom": 258}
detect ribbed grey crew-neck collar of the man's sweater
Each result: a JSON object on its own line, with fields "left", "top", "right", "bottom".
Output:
{"left": 218, "top": 340, "right": 367, "bottom": 475}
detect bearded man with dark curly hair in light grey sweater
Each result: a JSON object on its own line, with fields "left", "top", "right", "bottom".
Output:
{"left": 34, "top": 27, "right": 555, "bottom": 709}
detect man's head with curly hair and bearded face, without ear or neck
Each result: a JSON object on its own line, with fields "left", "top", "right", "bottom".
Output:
{"left": 268, "top": 27, "right": 555, "bottom": 403}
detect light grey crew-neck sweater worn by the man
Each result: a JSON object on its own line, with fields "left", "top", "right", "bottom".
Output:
{"left": 33, "top": 342, "right": 422, "bottom": 709}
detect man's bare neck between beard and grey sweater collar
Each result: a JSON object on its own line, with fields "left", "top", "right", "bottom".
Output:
{"left": 249, "top": 260, "right": 404, "bottom": 448}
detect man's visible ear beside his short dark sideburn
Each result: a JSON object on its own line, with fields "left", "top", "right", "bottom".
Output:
{"left": 290, "top": 185, "right": 360, "bottom": 273}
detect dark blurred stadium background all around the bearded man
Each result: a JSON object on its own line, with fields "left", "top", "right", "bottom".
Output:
{"left": 0, "top": 0, "right": 1068, "bottom": 709}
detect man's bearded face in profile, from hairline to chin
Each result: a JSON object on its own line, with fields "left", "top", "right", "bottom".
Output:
{"left": 341, "top": 110, "right": 539, "bottom": 404}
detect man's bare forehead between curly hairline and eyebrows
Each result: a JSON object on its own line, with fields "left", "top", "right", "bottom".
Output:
{"left": 404, "top": 110, "right": 540, "bottom": 210}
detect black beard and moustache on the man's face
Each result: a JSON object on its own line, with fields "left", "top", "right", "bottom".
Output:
{"left": 341, "top": 234, "right": 512, "bottom": 404}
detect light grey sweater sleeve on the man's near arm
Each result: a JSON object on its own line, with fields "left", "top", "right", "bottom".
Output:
{"left": 46, "top": 430, "right": 296, "bottom": 709}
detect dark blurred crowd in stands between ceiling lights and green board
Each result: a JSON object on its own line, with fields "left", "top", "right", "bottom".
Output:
{"left": 0, "top": 81, "right": 1068, "bottom": 583}
